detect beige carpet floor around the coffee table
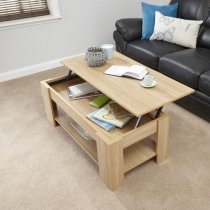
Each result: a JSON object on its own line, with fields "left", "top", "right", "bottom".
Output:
{"left": 0, "top": 68, "right": 210, "bottom": 210}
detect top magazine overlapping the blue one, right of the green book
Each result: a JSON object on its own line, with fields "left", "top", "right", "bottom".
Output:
{"left": 93, "top": 102, "right": 133, "bottom": 128}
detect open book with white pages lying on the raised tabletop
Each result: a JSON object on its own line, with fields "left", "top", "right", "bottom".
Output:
{"left": 104, "top": 65, "right": 148, "bottom": 80}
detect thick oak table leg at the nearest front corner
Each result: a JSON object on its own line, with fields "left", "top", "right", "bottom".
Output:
{"left": 97, "top": 140, "right": 124, "bottom": 190}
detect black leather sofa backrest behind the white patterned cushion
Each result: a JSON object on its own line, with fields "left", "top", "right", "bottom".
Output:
{"left": 170, "top": 0, "right": 210, "bottom": 49}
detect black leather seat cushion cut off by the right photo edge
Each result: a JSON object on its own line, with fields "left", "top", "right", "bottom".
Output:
{"left": 198, "top": 68, "right": 210, "bottom": 96}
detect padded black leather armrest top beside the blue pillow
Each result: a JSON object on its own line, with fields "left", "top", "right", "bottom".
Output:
{"left": 115, "top": 18, "right": 142, "bottom": 42}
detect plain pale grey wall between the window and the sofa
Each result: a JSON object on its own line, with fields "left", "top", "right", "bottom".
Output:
{"left": 0, "top": 0, "right": 169, "bottom": 73}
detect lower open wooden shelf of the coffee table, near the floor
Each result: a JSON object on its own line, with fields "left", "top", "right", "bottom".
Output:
{"left": 55, "top": 114, "right": 156, "bottom": 173}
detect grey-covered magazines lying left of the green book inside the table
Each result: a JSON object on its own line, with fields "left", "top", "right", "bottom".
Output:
{"left": 67, "top": 82, "right": 101, "bottom": 100}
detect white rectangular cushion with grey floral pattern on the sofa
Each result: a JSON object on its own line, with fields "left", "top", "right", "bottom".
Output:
{"left": 150, "top": 12, "right": 203, "bottom": 48}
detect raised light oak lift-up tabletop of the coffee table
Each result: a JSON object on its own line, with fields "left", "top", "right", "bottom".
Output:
{"left": 62, "top": 52, "right": 194, "bottom": 117}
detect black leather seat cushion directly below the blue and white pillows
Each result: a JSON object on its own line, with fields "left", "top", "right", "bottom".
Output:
{"left": 126, "top": 39, "right": 186, "bottom": 70}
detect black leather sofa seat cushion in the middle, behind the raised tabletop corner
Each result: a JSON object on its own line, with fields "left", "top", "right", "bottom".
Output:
{"left": 158, "top": 48, "right": 210, "bottom": 89}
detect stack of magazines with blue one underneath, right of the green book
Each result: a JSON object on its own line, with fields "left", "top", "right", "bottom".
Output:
{"left": 87, "top": 101, "right": 133, "bottom": 131}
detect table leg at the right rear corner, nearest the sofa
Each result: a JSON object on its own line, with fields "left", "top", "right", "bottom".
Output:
{"left": 156, "top": 115, "right": 169, "bottom": 163}
